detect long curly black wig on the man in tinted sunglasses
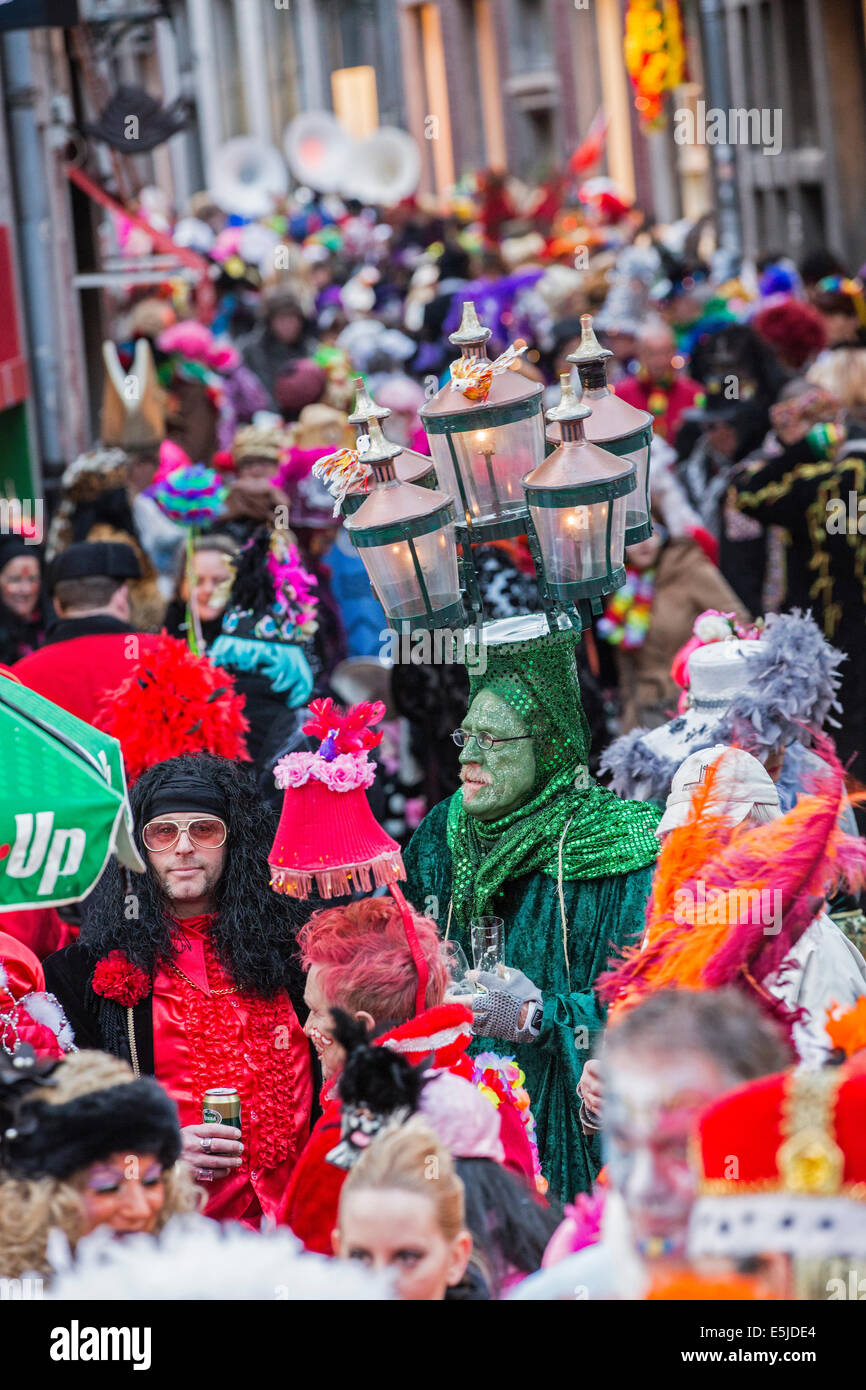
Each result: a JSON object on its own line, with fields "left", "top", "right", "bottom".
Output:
{"left": 81, "top": 753, "right": 316, "bottom": 1002}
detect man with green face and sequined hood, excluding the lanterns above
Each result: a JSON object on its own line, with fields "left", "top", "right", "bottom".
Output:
{"left": 405, "top": 630, "right": 659, "bottom": 1200}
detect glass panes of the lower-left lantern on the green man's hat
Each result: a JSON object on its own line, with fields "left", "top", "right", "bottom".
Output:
{"left": 359, "top": 521, "right": 460, "bottom": 621}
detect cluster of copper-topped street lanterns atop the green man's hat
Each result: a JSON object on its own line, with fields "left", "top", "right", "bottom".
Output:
{"left": 316, "top": 302, "right": 652, "bottom": 637}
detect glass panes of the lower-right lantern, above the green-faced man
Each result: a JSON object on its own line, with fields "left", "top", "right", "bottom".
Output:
{"left": 530, "top": 498, "right": 628, "bottom": 584}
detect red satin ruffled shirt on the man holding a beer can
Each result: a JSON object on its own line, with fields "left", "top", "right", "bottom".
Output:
{"left": 153, "top": 916, "right": 313, "bottom": 1227}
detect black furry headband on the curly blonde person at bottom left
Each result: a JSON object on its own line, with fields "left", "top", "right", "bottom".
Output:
{"left": 0, "top": 1077, "right": 181, "bottom": 1180}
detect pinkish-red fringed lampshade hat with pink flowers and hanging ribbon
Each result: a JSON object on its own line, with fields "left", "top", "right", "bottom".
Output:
{"left": 268, "top": 699, "right": 430, "bottom": 1013}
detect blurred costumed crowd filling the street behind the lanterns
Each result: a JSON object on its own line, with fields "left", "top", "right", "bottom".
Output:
{"left": 6, "top": 173, "right": 866, "bottom": 837}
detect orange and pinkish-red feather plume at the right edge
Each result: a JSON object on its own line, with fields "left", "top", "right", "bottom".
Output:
{"left": 599, "top": 738, "right": 866, "bottom": 1026}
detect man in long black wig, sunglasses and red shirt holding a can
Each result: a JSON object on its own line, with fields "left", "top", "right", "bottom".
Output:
{"left": 44, "top": 753, "right": 313, "bottom": 1226}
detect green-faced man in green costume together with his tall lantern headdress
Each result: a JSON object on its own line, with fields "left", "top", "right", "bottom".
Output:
{"left": 308, "top": 304, "right": 667, "bottom": 1198}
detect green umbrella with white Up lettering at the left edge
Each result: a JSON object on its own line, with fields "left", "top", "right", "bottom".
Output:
{"left": 0, "top": 677, "right": 145, "bottom": 913}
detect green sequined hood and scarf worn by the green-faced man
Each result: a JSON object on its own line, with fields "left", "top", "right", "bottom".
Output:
{"left": 448, "top": 631, "right": 660, "bottom": 927}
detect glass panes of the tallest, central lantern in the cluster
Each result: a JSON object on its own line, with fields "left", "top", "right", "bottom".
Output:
{"left": 428, "top": 414, "right": 545, "bottom": 525}
